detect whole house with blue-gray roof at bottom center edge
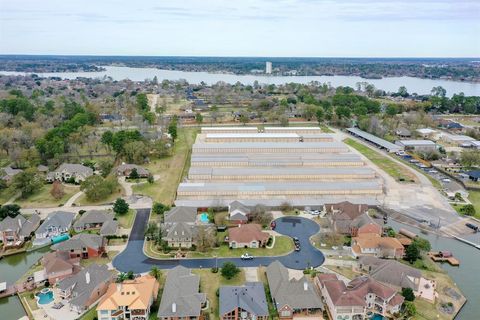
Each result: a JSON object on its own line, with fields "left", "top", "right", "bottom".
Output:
{"left": 219, "top": 282, "right": 269, "bottom": 320}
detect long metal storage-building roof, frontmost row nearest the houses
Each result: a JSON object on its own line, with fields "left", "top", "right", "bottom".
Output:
{"left": 178, "top": 181, "right": 381, "bottom": 192}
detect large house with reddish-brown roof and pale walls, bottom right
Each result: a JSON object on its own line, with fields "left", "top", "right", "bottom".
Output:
{"left": 315, "top": 274, "right": 404, "bottom": 319}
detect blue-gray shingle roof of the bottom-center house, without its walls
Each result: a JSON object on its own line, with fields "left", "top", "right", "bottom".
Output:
{"left": 219, "top": 282, "right": 268, "bottom": 316}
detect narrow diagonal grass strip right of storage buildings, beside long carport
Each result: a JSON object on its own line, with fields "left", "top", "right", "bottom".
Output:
{"left": 343, "top": 138, "right": 417, "bottom": 182}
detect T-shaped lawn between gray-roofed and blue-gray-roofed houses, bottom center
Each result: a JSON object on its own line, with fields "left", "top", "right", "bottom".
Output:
{"left": 192, "top": 269, "right": 245, "bottom": 319}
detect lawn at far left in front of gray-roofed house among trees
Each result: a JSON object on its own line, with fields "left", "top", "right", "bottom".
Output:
{"left": 15, "top": 184, "right": 80, "bottom": 208}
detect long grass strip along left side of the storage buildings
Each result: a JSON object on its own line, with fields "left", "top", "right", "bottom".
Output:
{"left": 133, "top": 128, "right": 199, "bottom": 205}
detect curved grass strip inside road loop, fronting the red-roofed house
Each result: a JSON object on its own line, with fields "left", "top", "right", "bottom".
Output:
{"left": 144, "top": 235, "right": 294, "bottom": 259}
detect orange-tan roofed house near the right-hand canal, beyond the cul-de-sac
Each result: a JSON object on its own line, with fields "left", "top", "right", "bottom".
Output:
{"left": 352, "top": 233, "right": 405, "bottom": 259}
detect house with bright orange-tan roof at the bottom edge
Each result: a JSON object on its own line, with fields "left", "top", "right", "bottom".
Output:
{"left": 97, "top": 274, "right": 159, "bottom": 320}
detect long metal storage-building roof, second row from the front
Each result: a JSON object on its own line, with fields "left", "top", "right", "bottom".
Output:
{"left": 189, "top": 167, "right": 375, "bottom": 176}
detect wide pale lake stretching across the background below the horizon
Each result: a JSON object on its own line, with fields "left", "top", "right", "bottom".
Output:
{"left": 0, "top": 66, "right": 480, "bottom": 96}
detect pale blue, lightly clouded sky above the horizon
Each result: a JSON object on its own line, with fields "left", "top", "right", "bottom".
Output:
{"left": 0, "top": 0, "right": 480, "bottom": 57}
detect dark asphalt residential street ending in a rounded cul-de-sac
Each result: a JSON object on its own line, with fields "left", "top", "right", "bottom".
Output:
{"left": 113, "top": 209, "right": 325, "bottom": 273}
